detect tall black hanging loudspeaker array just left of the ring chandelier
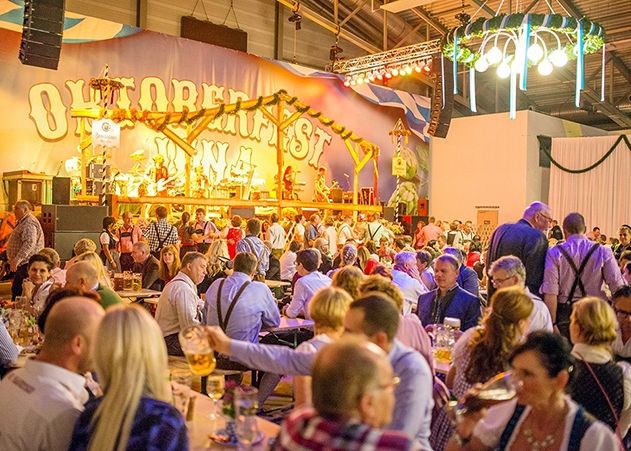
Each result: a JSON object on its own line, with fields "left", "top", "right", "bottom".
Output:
{"left": 428, "top": 54, "right": 454, "bottom": 138}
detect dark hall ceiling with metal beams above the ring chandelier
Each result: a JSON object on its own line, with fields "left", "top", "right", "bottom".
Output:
{"left": 292, "top": 0, "right": 631, "bottom": 130}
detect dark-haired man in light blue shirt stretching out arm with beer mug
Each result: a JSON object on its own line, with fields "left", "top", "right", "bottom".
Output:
{"left": 208, "top": 293, "right": 434, "bottom": 450}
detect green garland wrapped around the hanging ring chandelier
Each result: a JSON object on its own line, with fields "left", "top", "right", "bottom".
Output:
{"left": 443, "top": 13, "right": 605, "bottom": 66}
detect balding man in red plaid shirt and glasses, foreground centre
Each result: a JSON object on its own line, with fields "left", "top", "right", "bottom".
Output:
{"left": 276, "top": 337, "right": 412, "bottom": 451}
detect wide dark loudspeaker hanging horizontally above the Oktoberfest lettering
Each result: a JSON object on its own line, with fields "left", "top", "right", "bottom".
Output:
{"left": 180, "top": 16, "right": 248, "bottom": 52}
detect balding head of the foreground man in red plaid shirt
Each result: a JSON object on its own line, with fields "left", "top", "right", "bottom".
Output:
{"left": 311, "top": 336, "right": 392, "bottom": 423}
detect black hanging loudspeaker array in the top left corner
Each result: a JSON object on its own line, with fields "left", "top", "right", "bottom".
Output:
{"left": 19, "top": 0, "right": 65, "bottom": 70}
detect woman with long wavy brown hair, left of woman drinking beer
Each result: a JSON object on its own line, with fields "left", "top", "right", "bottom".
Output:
{"left": 430, "top": 287, "right": 533, "bottom": 450}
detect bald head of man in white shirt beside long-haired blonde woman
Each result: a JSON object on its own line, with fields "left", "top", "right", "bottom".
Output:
{"left": 42, "top": 296, "right": 105, "bottom": 373}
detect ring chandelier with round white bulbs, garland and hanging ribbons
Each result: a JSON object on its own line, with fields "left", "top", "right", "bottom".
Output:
{"left": 442, "top": 13, "right": 605, "bottom": 119}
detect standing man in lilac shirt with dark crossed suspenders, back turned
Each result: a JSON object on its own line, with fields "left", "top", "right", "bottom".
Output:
{"left": 541, "top": 213, "right": 624, "bottom": 339}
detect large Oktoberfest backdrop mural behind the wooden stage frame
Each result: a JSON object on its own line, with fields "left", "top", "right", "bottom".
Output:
{"left": 0, "top": 0, "right": 429, "bottom": 212}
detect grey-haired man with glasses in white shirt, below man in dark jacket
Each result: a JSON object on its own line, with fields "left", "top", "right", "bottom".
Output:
{"left": 489, "top": 255, "right": 553, "bottom": 334}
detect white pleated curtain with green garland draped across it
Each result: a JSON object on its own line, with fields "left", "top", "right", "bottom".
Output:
{"left": 549, "top": 136, "right": 631, "bottom": 238}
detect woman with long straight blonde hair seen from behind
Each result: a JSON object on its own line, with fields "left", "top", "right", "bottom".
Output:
{"left": 69, "top": 306, "right": 189, "bottom": 451}
